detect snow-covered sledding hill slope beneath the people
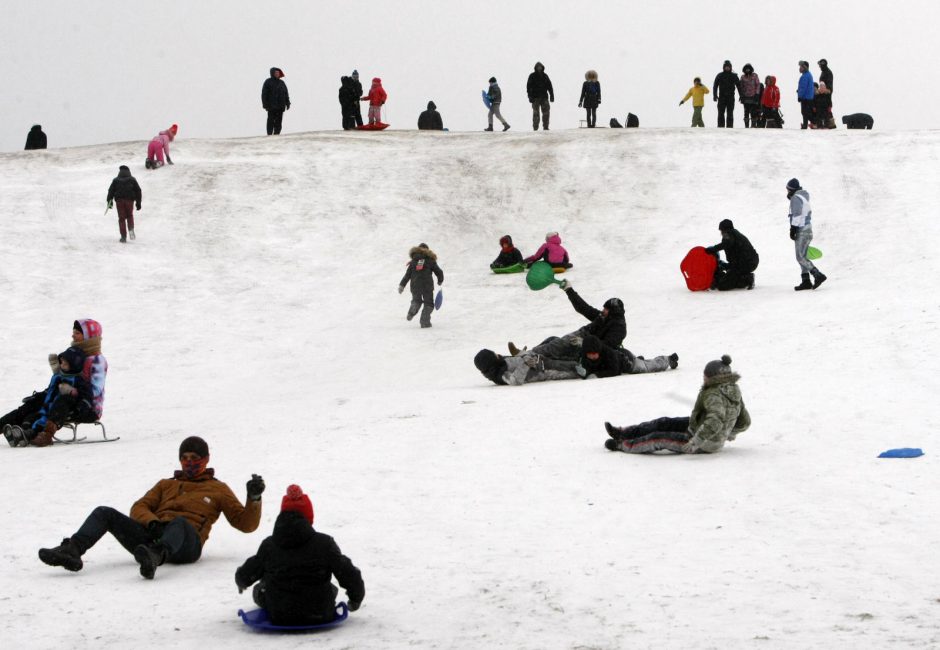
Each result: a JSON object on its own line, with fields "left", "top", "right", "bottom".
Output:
{"left": 0, "top": 129, "right": 940, "bottom": 648}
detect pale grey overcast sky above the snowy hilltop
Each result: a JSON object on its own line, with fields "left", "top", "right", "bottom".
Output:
{"left": 0, "top": 0, "right": 940, "bottom": 149}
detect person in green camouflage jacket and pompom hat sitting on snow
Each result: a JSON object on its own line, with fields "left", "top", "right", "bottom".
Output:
{"left": 604, "top": 354, "right": 751, "bottom": 454}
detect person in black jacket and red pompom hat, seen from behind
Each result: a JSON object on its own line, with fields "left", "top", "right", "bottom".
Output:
{"left": 235, "top": 485, "right": 366, "bottom": 625}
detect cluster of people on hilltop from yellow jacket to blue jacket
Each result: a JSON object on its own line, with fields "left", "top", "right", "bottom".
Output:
{"left": 679, "top": 59, "right": 835, "bottom": 129}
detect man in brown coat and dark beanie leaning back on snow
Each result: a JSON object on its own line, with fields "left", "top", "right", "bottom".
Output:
{"left": 39, "top": 436, "right": 264, "bottom": 580}
